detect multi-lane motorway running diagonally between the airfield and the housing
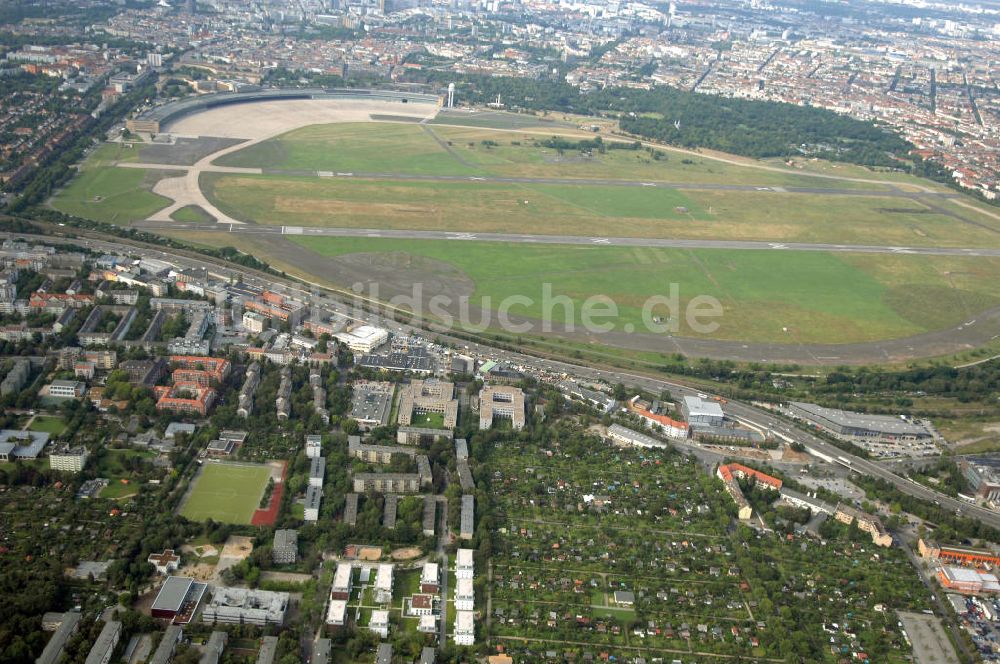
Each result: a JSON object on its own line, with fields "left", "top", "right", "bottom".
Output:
{"left": 19, "top": 229, "right": 1000, "bottom": 529}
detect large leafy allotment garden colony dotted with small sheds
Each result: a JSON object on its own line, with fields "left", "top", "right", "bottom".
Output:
{"left": 489, "top": 436, "right": 926, "bottom": 661}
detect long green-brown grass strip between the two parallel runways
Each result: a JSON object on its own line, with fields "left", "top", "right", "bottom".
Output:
{"left": 201, "top": 173, "right": 1000, "bottom": 247}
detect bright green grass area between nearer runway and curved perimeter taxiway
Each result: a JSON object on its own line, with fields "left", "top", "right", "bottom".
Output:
{"left": 294, "top": 237, "right": 1000, "bottom": 343}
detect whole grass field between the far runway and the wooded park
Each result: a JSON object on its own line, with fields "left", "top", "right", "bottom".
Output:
{"left": 215, "top": 123, "right": 919, "bottom": 190}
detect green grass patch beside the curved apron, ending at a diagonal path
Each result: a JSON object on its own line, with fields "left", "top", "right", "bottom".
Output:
{"left": 215, "top": 123, "right": 476, "bottom": 175}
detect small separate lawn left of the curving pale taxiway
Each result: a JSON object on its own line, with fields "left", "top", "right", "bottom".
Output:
{"left": 51, "top": 165, "right": 178, "bottom": 224}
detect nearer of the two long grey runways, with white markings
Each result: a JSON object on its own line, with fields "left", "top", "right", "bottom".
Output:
{"left": 132, "top": 221, "right": 1000, "bottom": 258}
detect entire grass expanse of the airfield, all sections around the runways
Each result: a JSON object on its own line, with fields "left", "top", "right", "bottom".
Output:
{"left": 52, "top": 114, "right": 1000, "bottom": 352}
